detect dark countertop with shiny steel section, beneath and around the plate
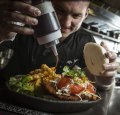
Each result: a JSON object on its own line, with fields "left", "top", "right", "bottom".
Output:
{"left": 0, "top": 80, "right": 120, "bottom": 115}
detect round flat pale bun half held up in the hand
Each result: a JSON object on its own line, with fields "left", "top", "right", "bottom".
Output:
{"left": 83, "top": 43, "right": 109, "bottom": 76}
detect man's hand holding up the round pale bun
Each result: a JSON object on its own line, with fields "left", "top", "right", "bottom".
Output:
{"left": 96, "top": 42, "right": 119, "bottom": 86}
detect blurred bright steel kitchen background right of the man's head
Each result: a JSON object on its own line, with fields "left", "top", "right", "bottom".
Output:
{"left": 82, "top": 0, "right": 120, "bottom": 72}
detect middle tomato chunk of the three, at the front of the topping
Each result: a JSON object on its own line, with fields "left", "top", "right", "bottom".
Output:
{"left": 70, "top": 84, "right": 85, "bottom": 94}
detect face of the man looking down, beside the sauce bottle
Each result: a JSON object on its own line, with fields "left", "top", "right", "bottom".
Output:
{"left": 52, "top": 0, "right": 89, "bottom": 40}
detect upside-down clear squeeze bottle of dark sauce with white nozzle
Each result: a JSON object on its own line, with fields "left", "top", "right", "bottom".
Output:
{"left": 32, "top": 0, "right": 62, "bottom": 56}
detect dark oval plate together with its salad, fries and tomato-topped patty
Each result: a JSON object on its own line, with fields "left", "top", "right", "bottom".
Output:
{"left": 6, "top": 64, "right": 101, "bottom": 113}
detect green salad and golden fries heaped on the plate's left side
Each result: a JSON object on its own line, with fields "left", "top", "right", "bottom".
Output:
{"left": 8, "top": 64, "right": 58, "bottom": 96}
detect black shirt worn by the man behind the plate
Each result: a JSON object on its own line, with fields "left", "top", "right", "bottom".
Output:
{"left": 0, "top": 29, "right": 95, "bottom": 81}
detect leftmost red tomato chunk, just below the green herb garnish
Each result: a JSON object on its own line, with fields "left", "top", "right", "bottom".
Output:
{"left": 57, "top": 77, "right": 71, "bottom": 89}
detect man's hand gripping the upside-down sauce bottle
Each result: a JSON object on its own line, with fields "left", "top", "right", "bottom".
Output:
{"left": 0, "top": 0, "right": 41, "bottom": 41}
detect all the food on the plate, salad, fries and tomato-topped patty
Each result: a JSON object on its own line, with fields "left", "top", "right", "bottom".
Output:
{"left": 8, "top": 64, "right": 100, "bottom": 101}
